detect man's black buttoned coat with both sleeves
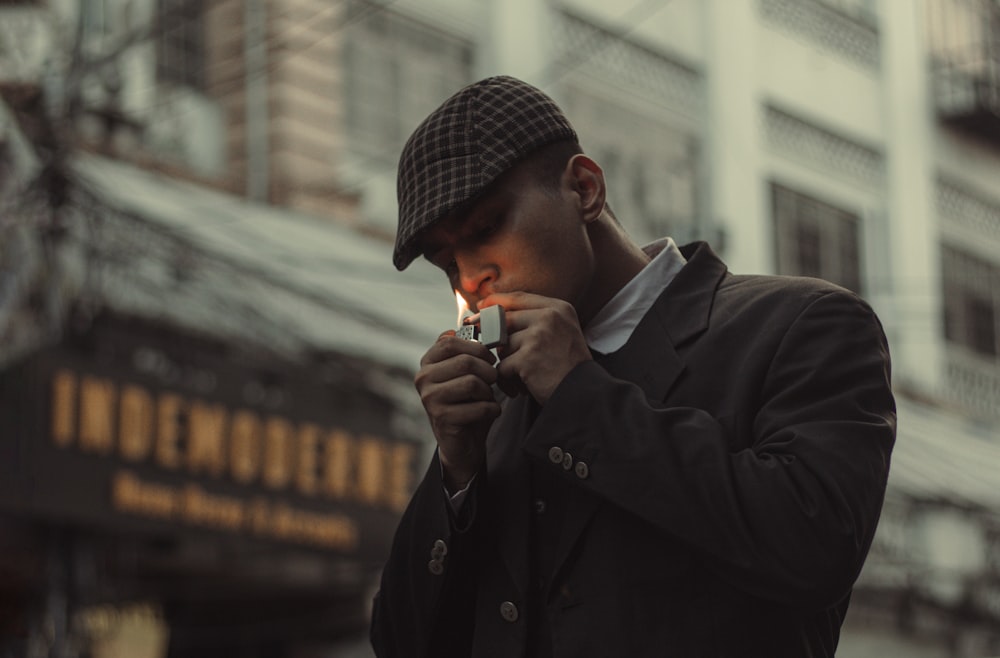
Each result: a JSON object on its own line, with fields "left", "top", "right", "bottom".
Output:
{"left": 372, "top": 243, "right": 895, "bottom": 658}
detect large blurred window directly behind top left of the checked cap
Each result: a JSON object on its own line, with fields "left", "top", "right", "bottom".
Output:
{"left": 344, "top": 1, "right": 472, "bottom": 165}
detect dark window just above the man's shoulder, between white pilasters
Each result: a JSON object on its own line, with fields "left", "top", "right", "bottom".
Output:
{"left": 771, "top": 183, "right": 861, "bottom": 293}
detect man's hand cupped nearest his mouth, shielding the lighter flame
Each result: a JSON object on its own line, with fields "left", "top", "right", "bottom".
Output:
{"left": 478, "top": 292, "right": 592, "bottom": 405}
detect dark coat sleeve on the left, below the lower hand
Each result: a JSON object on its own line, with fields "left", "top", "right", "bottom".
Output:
{"left": 370, "top": 452, "right": 486, "bottom": 658}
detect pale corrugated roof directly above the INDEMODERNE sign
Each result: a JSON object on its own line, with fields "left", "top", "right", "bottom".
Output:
{"left": 76, "top": 151, "right": 455, "bottom": 370}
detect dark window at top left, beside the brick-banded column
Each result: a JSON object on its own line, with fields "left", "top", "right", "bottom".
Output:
{"left": 155, "top": 0, "right": 205, "bottom": 89}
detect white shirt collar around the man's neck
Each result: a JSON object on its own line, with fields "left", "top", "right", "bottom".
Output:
{"left": 583, "top": 238, "right": 687, "bottom": 354}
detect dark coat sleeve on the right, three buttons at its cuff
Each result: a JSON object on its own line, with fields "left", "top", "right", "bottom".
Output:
{"left": 525, "top": 291, "right": 895, "bottom": 609}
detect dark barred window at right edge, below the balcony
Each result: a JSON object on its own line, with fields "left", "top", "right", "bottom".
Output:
{"left": 941, "top": 245, "right": 1000, "bottom": 358}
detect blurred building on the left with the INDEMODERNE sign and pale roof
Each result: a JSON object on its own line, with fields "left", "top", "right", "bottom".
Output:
{"left": 0, "top": 3, "right": 455, "bottom": 656}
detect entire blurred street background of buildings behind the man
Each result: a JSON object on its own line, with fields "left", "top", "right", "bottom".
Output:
{"left": 0, "top": 0, "right": 1000, "bottom": 658}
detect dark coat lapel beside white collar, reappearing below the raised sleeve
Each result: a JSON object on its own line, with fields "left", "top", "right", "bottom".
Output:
{"left": 553, "top": 243, "right": 726, "bottom": 575}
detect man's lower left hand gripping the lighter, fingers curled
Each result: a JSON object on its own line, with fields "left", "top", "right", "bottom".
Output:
{"left": 414, "top": 331, "right": 500, "bottom": 491}
